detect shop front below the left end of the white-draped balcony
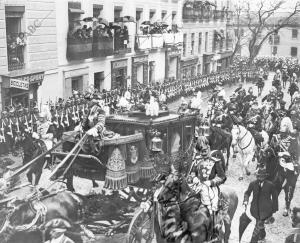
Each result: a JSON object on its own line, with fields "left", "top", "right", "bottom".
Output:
{"left": 131, "top": 55, "right": 149, "bottom": 87}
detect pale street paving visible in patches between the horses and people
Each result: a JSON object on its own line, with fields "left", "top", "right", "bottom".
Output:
{"left": 6, "top": 74, "right": 300, "bottom": 243}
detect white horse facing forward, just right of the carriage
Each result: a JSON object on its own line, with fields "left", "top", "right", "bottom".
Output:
{"left": 231, "top": 125, "right": 256, "bottom": 180}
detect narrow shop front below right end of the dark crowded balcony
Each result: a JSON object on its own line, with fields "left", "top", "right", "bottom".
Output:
{"left": 111, "top": 59, "right": 127, "bottom": 89}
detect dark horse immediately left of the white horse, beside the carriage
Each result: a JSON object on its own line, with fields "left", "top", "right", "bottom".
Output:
{"left": 207, "top": 126, "right": 232, "bottom": 168}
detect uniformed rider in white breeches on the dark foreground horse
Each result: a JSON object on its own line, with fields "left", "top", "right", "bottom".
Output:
{"left": 190, "top": 137, "right": 227, "bottom": 239}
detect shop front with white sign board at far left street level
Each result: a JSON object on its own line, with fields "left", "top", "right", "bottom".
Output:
{"left": 2, "top": 72, "right": 44, "bottom": 108}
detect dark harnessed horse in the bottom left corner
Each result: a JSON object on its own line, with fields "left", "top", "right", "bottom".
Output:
{"left": 0, "top": 191, "right": 87, "bottom": 243}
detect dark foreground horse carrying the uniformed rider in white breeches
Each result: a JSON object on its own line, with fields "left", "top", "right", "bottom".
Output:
{"left": 158, "top": 174, "right": 238, "bottom": 243}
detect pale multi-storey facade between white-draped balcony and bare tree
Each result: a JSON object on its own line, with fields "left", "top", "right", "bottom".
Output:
{"left": 181, "top": 1, "right": 232, "bottom": 78}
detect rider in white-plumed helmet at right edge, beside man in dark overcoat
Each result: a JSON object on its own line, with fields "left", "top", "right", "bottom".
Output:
{"left": 270, "top": 117, "right": 300, "bottom": 216}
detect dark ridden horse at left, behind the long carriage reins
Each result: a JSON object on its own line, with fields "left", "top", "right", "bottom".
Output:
{"left": 20, "top": 133, "right": 47, "bottom": 186}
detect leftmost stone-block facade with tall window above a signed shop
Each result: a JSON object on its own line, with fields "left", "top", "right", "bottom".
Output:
{"left": 0, "top": 0, "right": 58, "bottom": 107}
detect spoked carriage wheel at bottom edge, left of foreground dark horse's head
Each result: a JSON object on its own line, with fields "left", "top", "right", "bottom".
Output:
{"left": 127, "top": 209, "right": 154, "bottom": 243}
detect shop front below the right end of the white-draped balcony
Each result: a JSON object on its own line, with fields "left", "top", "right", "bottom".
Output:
{"left": 166, "top": 48, "right": 181, "bottom": 79}
